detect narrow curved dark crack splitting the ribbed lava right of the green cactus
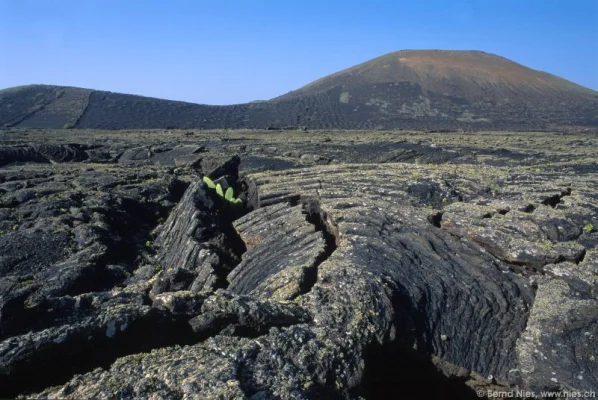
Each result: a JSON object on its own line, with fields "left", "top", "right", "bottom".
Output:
{"left": 299, "top": 199, "right": 339, "bottom": 295}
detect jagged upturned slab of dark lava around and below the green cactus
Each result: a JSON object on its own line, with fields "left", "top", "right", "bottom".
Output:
{"left": 150, "top": 156, "right": 258, "bottom": 296}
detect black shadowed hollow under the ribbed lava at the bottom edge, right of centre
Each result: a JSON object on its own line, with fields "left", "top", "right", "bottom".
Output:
{"left": 350, "top": 341, "right": 479, "bottom": 400}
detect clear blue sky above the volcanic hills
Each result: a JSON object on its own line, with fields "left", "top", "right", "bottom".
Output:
{"left": 0, "top": 0, "right": 598, "bottom": 104}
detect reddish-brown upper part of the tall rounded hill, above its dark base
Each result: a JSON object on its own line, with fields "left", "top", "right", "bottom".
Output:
{"left": 279, "top": 50, "right": 596, "bottom": 99}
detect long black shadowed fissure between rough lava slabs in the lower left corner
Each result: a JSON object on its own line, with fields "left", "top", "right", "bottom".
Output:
{"left": 0, "top": 303, "right": 202, "bottom": 397}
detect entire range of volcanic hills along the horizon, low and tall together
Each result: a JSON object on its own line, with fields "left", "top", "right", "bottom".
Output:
{"left": 0, "top": 50, "right": 598, "bottom": 129}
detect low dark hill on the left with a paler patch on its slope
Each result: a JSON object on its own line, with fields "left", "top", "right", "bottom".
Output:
{"left": 0, "top": 85, "right": 252, "bottom": 129}
